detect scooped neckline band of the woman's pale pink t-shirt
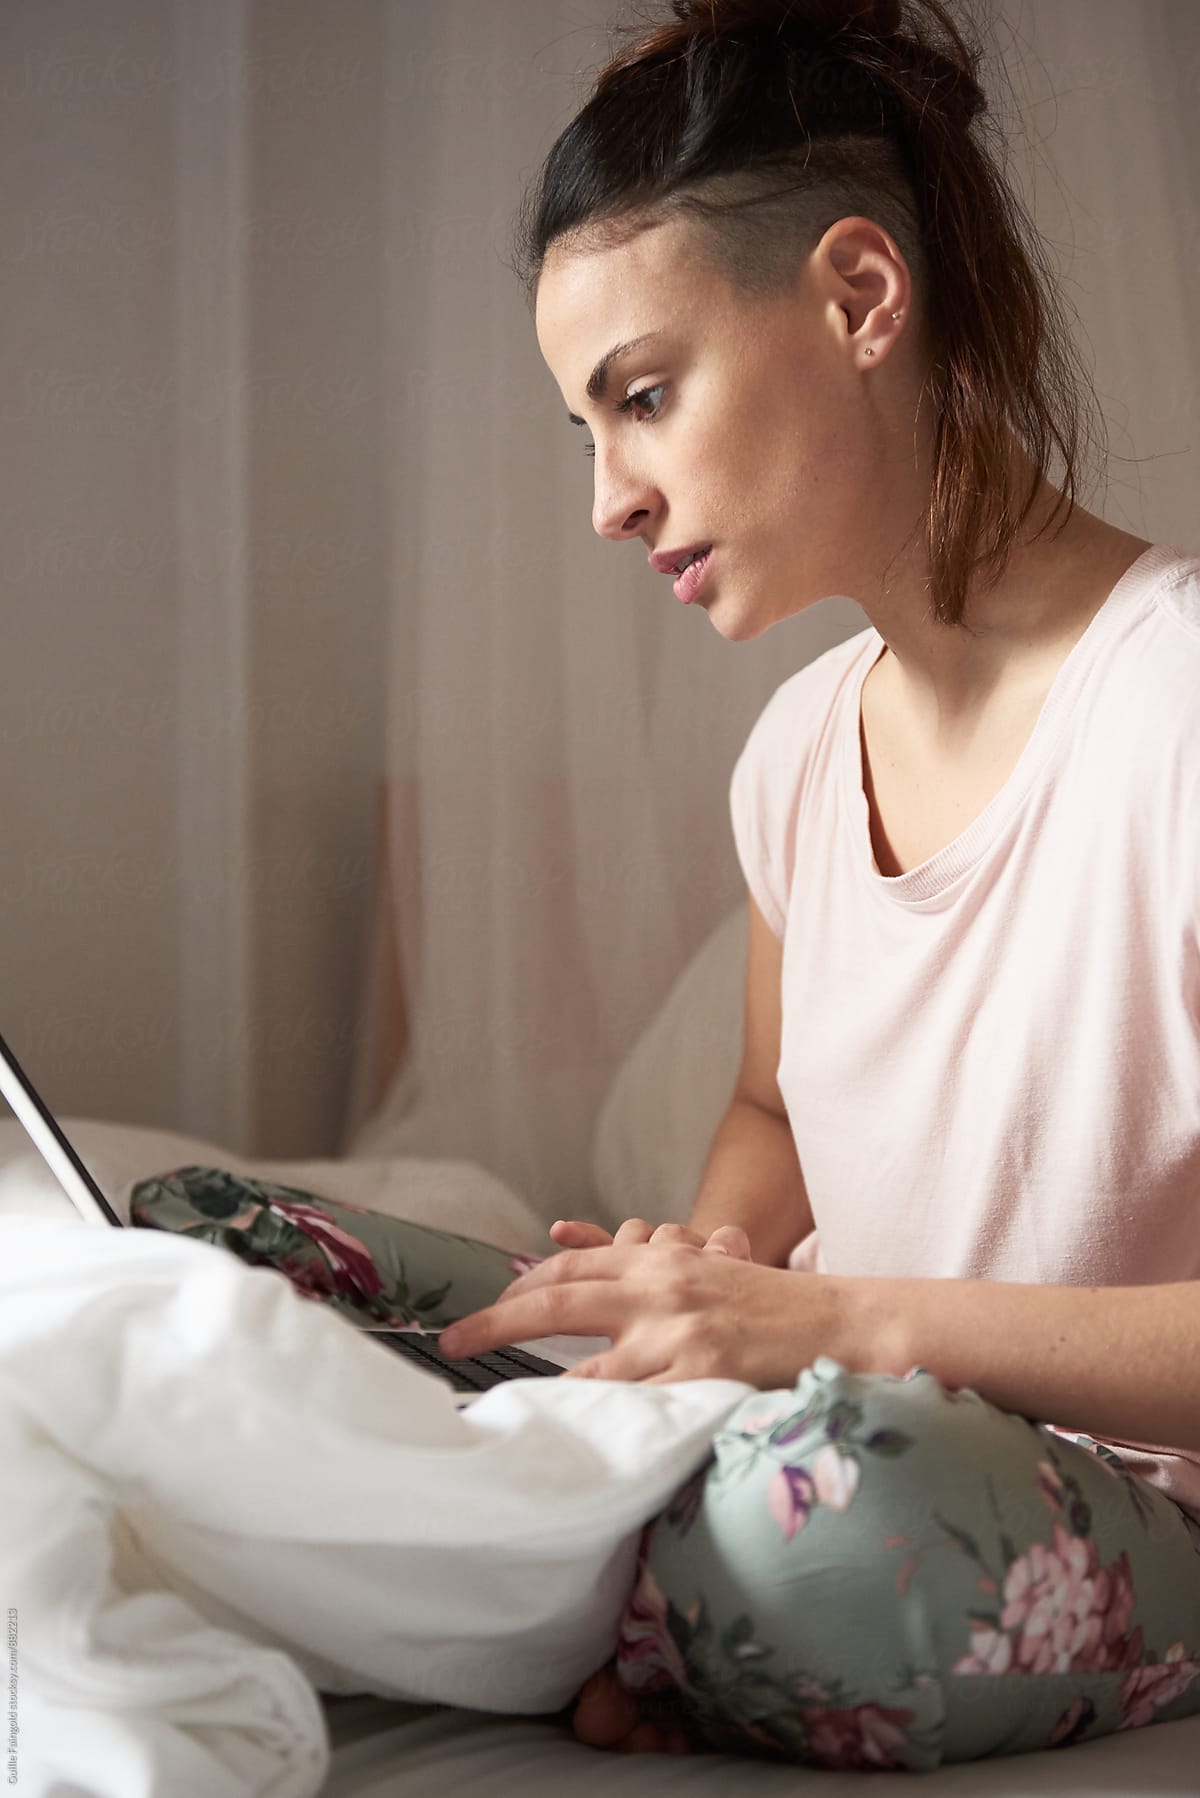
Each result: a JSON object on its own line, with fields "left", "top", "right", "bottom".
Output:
{"left": 842, "top": 543, "right": 1180, "bottom": 904}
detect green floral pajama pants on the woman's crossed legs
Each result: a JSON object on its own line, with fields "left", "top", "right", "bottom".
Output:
{"left": 131, "top": 1169, "right": 1200, "bottom": 1771}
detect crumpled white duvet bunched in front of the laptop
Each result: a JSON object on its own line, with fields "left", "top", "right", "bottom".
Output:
{"left": 0, "top": 1138, "right": 748, "bottom": 1798}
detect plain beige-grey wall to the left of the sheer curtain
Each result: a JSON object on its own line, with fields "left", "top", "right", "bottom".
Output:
{"left": 0, "top": 0, "right": 387, "bottom": 1154}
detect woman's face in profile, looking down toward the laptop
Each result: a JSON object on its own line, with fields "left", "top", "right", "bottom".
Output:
{"left": 536, "top": 218, "right": 914, "bottom": 640}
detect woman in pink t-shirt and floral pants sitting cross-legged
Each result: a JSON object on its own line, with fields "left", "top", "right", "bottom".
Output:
{"left": 443, "top": 0, "right": 1200, "bottom": 1767}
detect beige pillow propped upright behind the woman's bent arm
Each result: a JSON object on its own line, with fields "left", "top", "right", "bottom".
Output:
{"left": 592, "top": 901, "right": 748, "bottom": 1230}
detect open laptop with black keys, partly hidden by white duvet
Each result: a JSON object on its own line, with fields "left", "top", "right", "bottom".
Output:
{"left": 0, "top": 1036, "right": 608, "bottom": 1408}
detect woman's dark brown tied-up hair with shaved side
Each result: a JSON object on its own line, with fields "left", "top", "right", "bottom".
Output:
{"left": 516, "top": 0, "right": 1103, "bottom": 624}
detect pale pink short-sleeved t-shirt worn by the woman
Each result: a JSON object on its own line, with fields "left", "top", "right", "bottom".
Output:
{"left": 730, "top": 545, "right": 1200, "bottom": 1516}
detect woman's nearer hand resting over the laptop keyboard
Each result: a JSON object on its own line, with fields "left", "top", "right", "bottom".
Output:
{"left": 441, "top": 1226, "right": 834, "bottom": 1386}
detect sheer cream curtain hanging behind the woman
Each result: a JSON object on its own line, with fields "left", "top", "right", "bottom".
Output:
{"left": 347, "top": 0, "right": 1200, "bottom": 1217}
